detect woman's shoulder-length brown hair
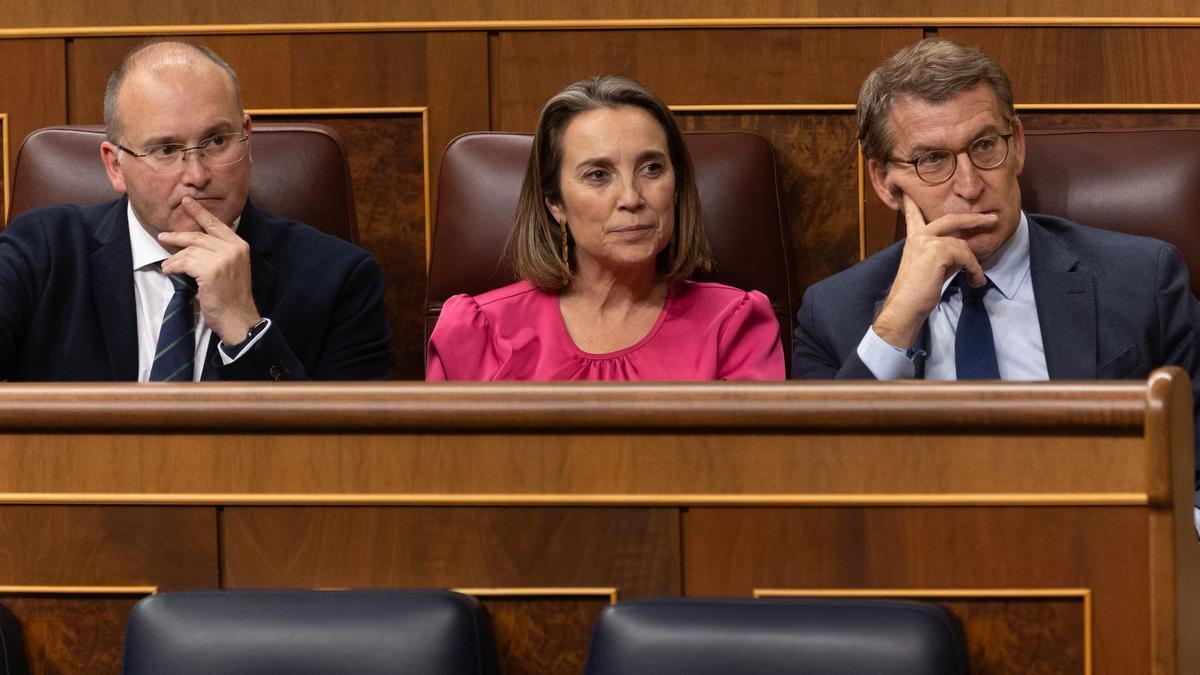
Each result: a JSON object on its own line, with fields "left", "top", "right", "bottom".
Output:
{"left": 504, "top": 76, "right": 712, "bottom": 291}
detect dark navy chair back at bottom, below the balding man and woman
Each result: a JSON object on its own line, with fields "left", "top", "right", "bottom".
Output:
{"left": 125, "top": 591, "right": 494, "bottom": 675}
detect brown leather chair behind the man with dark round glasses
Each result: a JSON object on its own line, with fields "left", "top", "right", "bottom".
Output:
{"left": 896, "top": 129, "right": 1200, "bottom": 293}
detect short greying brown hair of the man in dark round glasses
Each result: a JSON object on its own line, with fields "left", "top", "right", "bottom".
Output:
{"left": 858, "top": 38, "right": 1016, "bottom": 162}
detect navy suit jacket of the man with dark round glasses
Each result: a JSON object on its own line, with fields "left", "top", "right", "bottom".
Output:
{"left": 792, "top": 214, "right": 1200, "bottom": 503}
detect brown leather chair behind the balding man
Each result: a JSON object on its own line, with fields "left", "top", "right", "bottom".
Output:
{"left": 10, "top": 123, "right": 358, "bottom": 241}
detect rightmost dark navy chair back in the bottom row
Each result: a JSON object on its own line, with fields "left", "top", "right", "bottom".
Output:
{"left": 587, "top": 598, "right": 967, "bottom": 675}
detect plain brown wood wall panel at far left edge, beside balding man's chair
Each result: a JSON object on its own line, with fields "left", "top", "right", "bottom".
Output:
{"left": 0, "top": 40, "right": 67, "bottom": 210}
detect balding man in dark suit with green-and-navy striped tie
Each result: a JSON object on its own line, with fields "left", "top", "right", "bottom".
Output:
{"left": 0, "top": 42, "right": 391, "bottom": 382}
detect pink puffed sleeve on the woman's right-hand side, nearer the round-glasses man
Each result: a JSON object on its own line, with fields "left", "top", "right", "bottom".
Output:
{"left": 718, "top": 291, "right": 787, "bottom": 380}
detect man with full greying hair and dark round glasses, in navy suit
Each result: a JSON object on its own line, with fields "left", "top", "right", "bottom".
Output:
{"left": 792, "top": 40, "right": 1200, "bottom": 514}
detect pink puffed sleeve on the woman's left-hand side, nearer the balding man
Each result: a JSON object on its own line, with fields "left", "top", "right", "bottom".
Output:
{"left": 425, "top": 295, "right": 500, "bottom": 382}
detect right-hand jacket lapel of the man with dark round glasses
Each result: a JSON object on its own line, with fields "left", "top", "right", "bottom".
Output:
{"left": 1028, "top": 216, "right": 1096, "bottom": 380}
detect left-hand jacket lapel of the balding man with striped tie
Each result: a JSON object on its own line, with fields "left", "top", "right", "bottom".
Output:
{"left": 89, "top": 199, "right": 138, "bottom": 382}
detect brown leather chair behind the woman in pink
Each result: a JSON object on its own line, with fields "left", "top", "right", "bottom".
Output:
{"left": 425, "top": 132, "right": 799, "bottom": 358}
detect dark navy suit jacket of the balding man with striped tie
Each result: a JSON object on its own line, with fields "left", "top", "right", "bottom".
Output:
{"left": 0, "top": 198, "right": 391, "bottom": 382}
